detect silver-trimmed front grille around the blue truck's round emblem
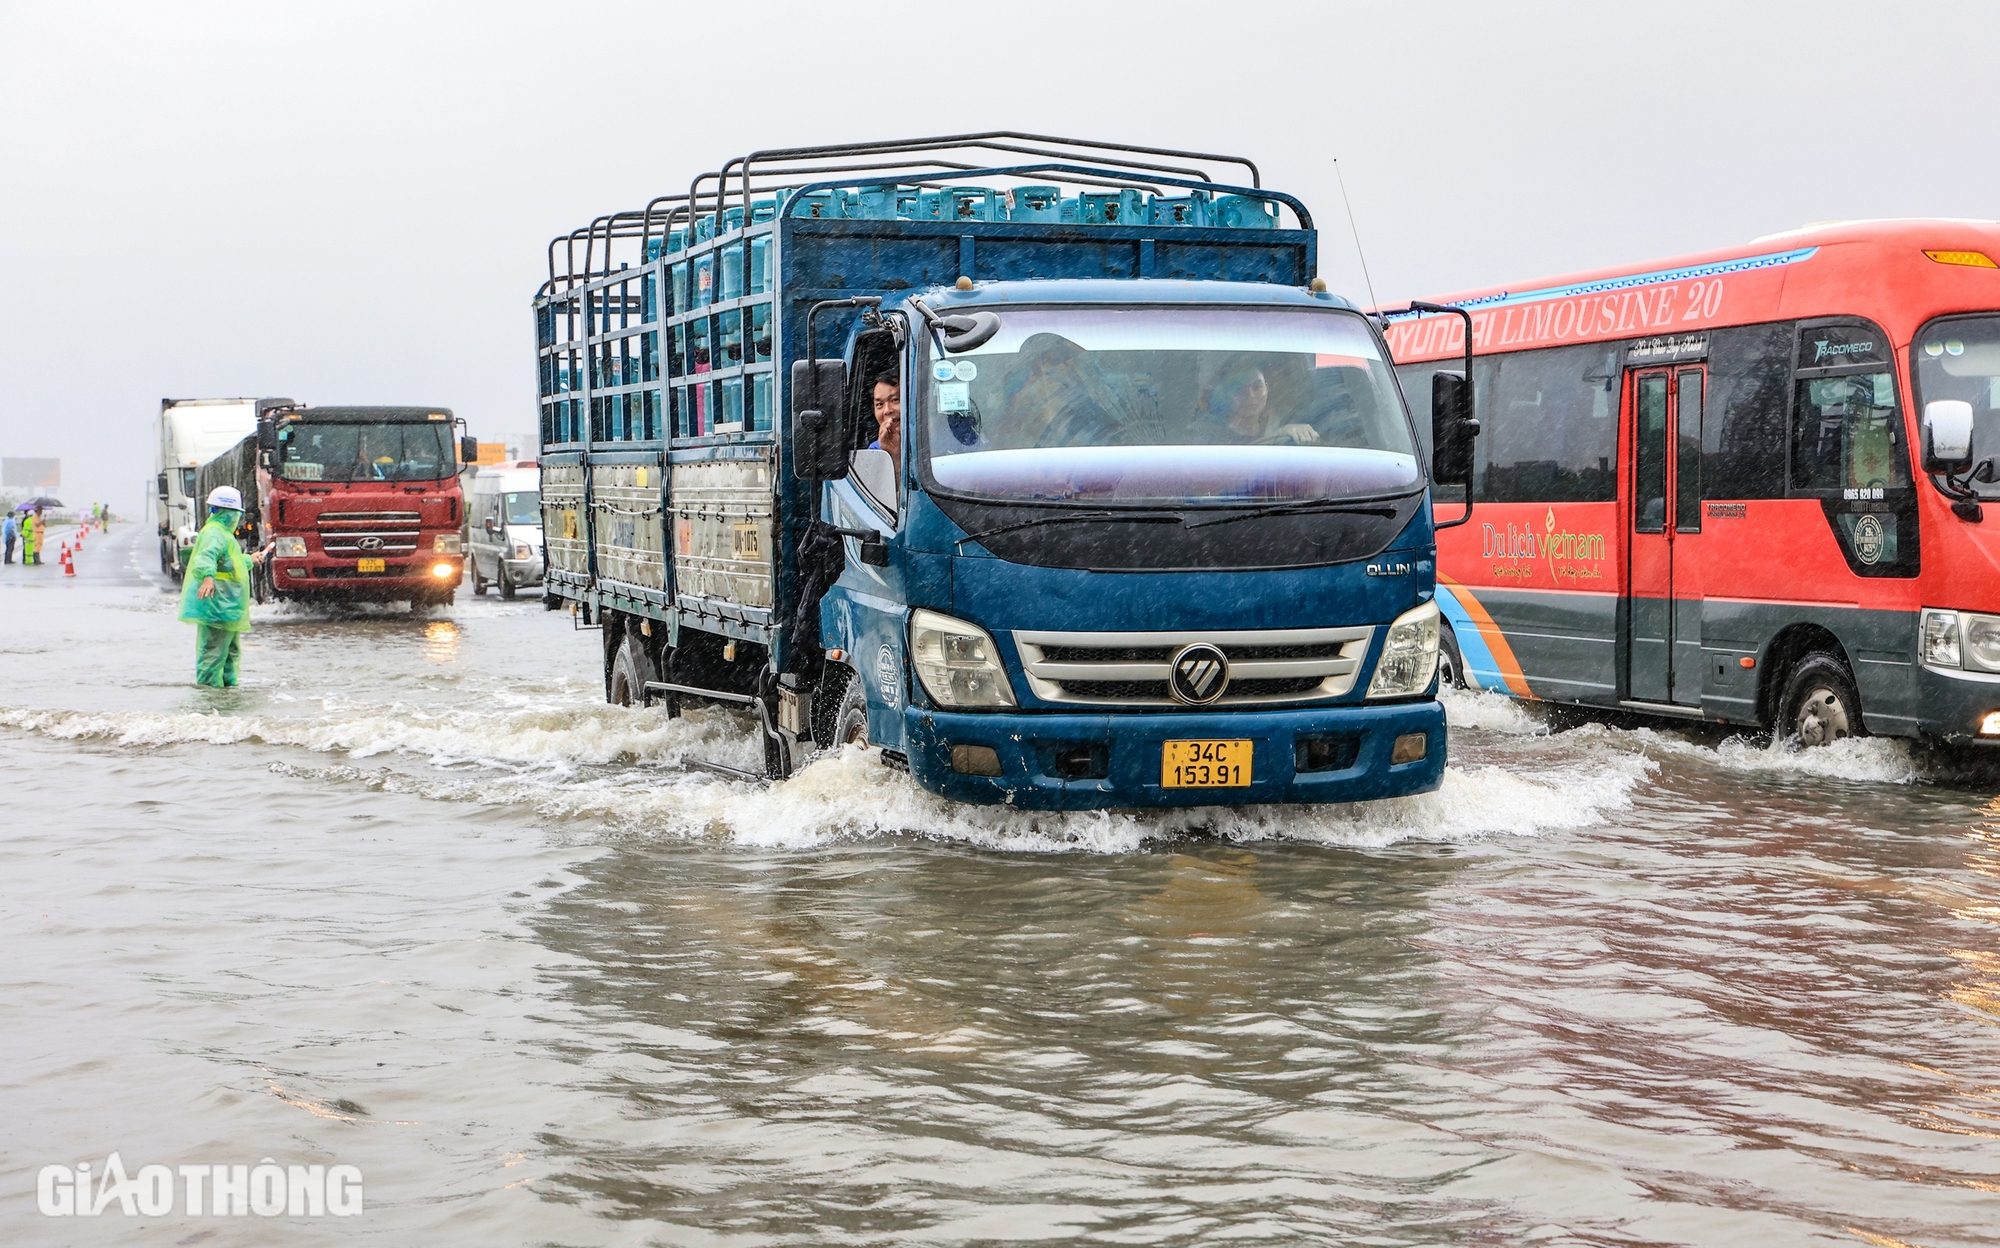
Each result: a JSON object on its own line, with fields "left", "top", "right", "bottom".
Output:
{"left": 1014, "top": 626, "right": 1374, "bottom": 706}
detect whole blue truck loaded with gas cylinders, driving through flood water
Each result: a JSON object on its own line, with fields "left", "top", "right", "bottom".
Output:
{"left": 534, "top": 132, "right": 1476, "bottom": 810}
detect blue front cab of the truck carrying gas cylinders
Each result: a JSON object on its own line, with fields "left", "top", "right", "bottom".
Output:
{"left": 794, "top": 280, "right": 1444, "bottom": 808}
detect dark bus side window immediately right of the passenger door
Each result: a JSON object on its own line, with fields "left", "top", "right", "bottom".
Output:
{"left": 1702, "top": 322, "right": 1792, "bottom": 498}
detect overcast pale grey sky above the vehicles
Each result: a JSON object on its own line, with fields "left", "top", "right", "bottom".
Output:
{"left": 0, "top": 0, "right": 2000, "bottom": 514}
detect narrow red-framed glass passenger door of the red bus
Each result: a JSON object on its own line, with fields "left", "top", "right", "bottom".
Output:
{"left": 1626, "top": 364, "right": 1706, "bottom": 706}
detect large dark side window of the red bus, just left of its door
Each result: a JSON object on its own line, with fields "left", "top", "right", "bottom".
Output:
{"left": 1474, "top": 346, "right": 1620, "bottom": 502}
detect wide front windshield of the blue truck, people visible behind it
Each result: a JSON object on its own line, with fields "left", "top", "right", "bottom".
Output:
{"left": 916, "top": 308, "right": 1422, "bottom": 506}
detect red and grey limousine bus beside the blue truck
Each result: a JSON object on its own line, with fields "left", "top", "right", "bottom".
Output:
{"left": 1388, "top": 220, "right": 2000, "bottom": 744}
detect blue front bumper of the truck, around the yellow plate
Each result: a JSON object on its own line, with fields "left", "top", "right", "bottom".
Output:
{"left": 904, "top": 700, "right": 1444, "bottom": 810}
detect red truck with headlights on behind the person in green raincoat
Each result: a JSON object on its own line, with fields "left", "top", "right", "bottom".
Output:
{"left": 200, "top": 406, "right": 478, "bottom": 608}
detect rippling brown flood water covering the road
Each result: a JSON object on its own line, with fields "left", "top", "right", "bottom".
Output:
{"left": 0, "top": 526, "right": 2000, "bottom": 1248}
